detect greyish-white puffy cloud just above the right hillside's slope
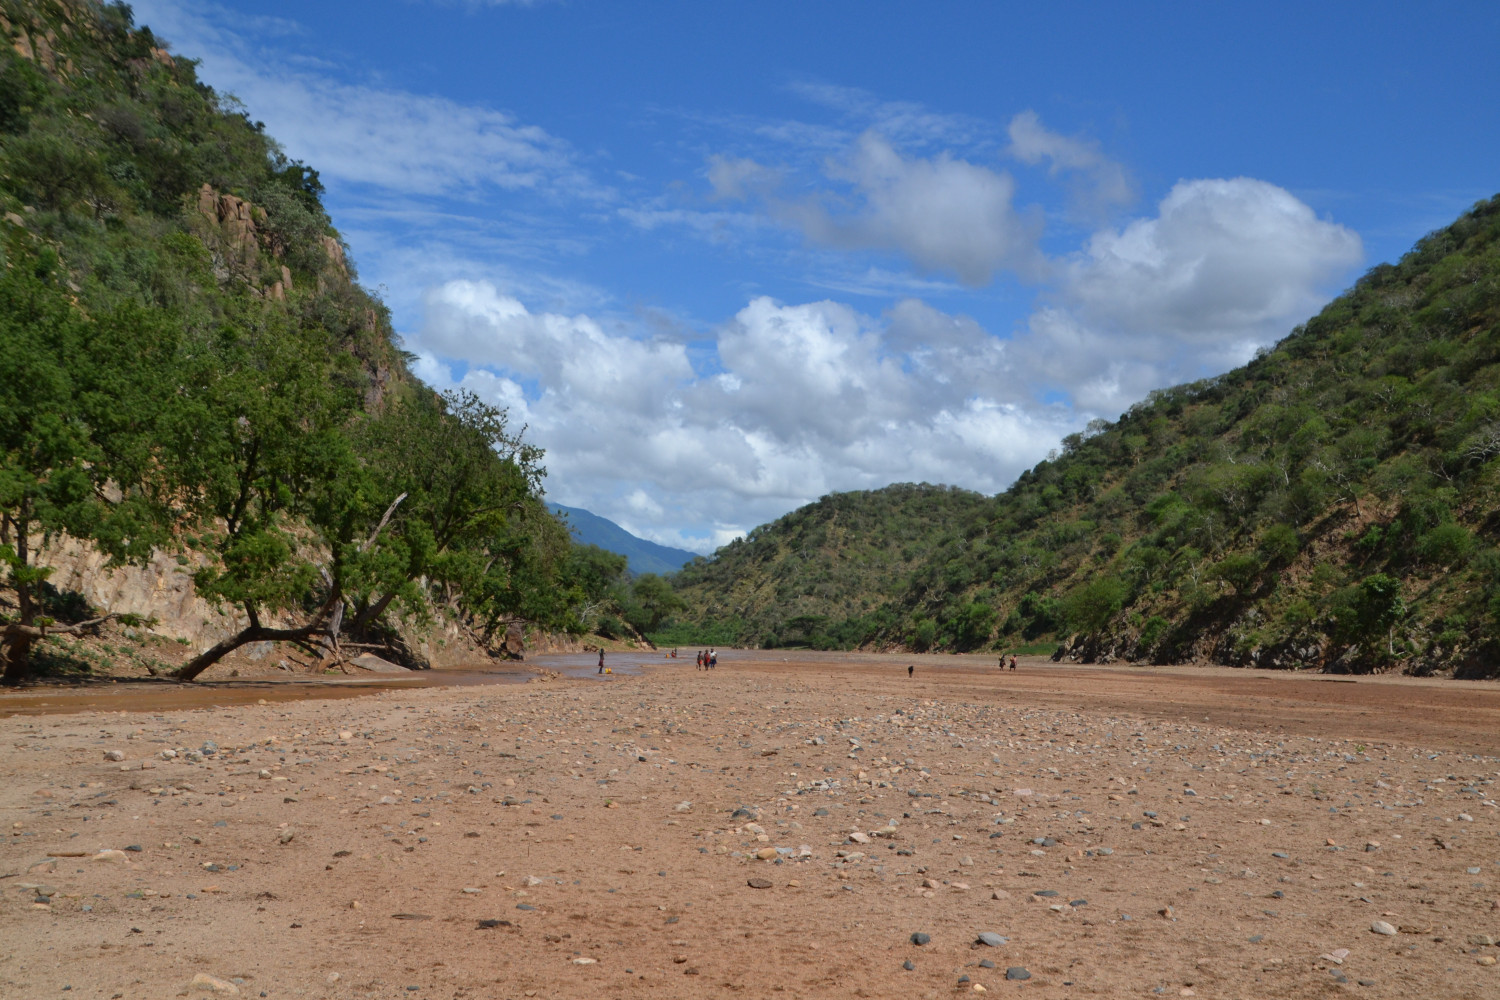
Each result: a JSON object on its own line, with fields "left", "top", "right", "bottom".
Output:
{"left": 1014, "top": 177, "right": 1364, "bottom": 415}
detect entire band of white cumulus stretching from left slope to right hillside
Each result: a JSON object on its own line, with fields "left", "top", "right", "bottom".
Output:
{"left": 413, "top": 178, "right": 1361, "bottom": 552}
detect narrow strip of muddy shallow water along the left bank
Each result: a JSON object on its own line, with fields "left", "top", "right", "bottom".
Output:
{"left": 0, "top": 651, "right": 662, "bottom": 718}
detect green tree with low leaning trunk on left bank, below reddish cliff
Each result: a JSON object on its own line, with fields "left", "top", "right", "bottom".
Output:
{"left": 165, "top": 312, "right": 369, "bottom": 681}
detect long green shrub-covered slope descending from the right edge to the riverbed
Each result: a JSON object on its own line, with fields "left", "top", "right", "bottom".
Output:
{"left": 683, "top": 199, "right": 1500, "bottom": 676}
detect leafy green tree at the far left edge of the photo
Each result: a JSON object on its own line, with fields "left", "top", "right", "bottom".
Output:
{"left": 0, "top": 253, "right": 177, "bottom": 684}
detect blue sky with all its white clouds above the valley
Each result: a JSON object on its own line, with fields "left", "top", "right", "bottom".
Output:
{"left": 134, "top": 0, "right": 1500, "bottom": 552}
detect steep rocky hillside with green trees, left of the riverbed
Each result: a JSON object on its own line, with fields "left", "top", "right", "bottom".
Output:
{"left": 0, "top": 0, "right": 606, "bottom": 682}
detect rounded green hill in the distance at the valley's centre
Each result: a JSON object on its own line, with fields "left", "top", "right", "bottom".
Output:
{"left": 674, "top": 483, "right": 990, "bottom": 649}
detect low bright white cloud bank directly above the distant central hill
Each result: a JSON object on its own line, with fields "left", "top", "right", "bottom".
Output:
{"left": 411, "top": 282, "right": 1083, "bottom": 550}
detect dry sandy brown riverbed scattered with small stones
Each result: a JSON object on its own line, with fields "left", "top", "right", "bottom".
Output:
{"left": 0, "top": 654, "right": 1500, "bottom": 1000}
